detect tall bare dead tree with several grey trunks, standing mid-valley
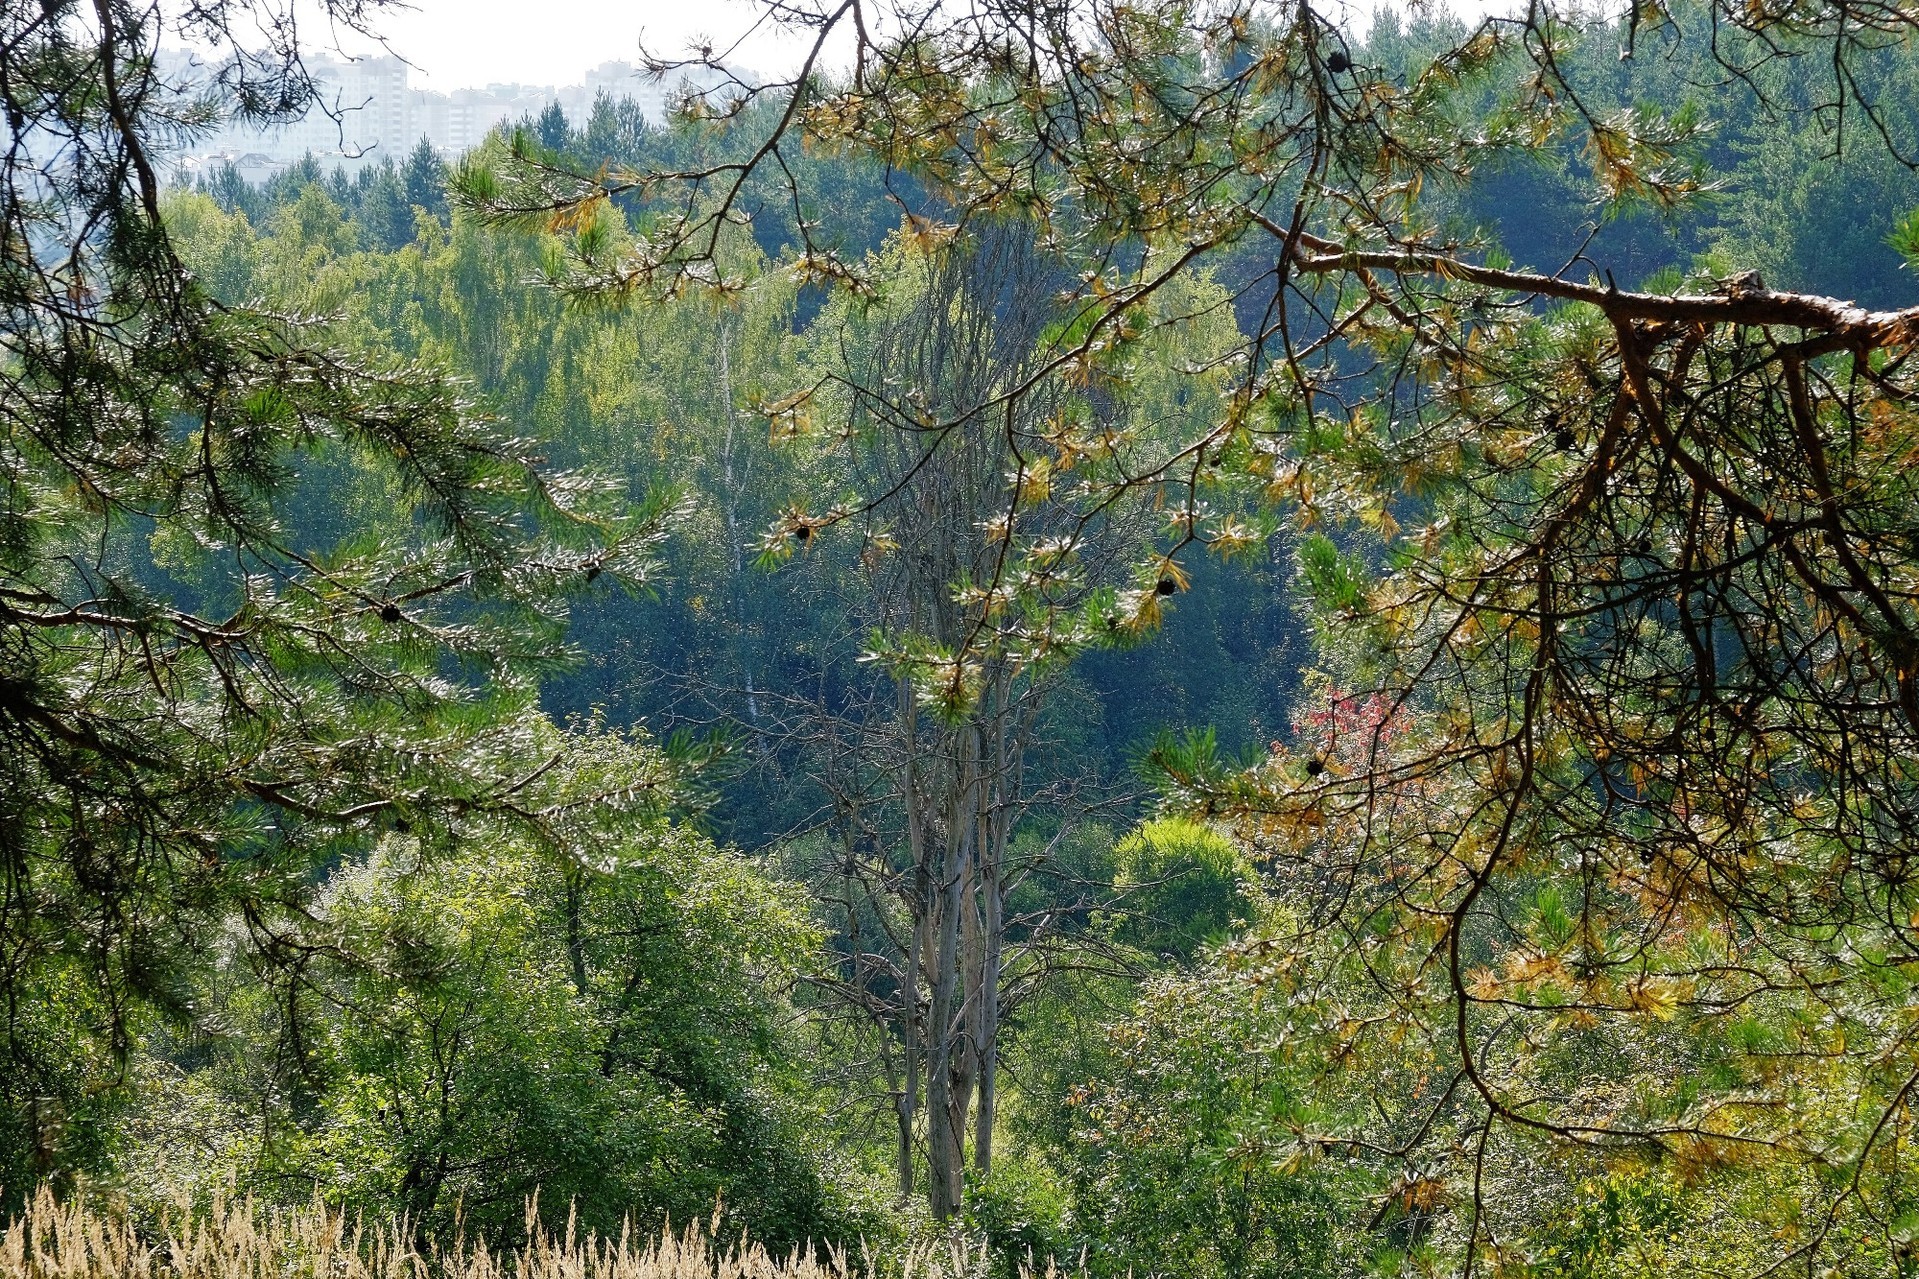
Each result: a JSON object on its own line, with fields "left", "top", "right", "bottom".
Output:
{"left": 796, "top": 225, "right": 1125, "bottom": 1218}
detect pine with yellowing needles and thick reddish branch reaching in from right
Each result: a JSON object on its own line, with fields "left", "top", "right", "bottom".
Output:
{"left": 461, "top": 0, "right": 1919, "bottom": 1244}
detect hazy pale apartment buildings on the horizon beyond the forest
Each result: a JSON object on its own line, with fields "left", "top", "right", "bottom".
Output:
{"left": 163, "top": 54, "right": 736, "bottom": 181}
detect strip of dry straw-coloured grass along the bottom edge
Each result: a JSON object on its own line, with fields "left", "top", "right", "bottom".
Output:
{"left": 0, "top": 1191, "right": 1005, "bottom": 1279}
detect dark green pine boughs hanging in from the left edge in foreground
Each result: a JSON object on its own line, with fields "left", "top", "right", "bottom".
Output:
{"left": 0, "top": 0, "right": 656, "bottom": 1195}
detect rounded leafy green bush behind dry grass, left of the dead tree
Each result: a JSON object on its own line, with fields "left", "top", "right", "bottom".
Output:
{"left": 117, "top": 737, "right": 846, "bottom": 1243}
